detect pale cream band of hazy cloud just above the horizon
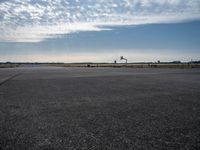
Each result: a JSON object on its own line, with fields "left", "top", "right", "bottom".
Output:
{"left": 0, "top": 51, "right": 199, "bottom": 63}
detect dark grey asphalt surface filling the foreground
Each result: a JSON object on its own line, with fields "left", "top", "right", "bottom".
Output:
{"left": 0, "top": 66, "right": 200, "bottom": 150}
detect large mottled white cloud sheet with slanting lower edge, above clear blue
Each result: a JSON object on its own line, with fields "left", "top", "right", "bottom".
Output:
{"left": 0, "top": 0, "right": 200, "bottom": 42}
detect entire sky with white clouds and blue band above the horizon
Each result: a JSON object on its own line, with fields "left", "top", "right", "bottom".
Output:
{"left": 0, "top": 0, "right": 200, "bottom": 63}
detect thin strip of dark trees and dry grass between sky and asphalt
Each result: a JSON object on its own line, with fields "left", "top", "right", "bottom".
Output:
{"left": 0, "top": 61, "right": 200, "bottom": 68}
